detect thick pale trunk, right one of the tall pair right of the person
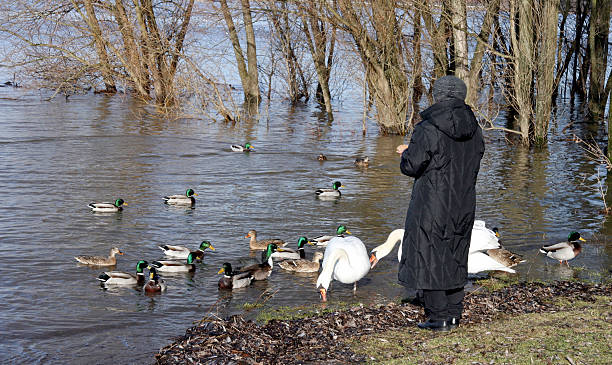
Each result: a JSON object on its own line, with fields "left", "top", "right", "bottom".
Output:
{"left": 534, "top": 0, "right": 559, "bottom": 145}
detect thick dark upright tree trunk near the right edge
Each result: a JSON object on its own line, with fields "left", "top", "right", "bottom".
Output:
{"left": 587, "top": 0, "right": 610, "bottom": 122}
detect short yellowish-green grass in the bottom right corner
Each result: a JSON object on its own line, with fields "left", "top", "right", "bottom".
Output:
{"left": 349, "top": 297, "right": 612, "bottom": 364}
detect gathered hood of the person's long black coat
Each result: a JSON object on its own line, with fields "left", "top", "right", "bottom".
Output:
{"left": 421, "top": 98, "right": 478, "bottom": 141}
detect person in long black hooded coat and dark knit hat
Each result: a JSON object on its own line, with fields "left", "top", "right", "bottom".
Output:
{"left": 397, "top": 76, "right": 484, "bottom": 331}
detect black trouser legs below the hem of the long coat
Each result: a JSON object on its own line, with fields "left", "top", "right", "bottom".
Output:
{"left": 423, "top": 288, "right": 465, "bottom": 321}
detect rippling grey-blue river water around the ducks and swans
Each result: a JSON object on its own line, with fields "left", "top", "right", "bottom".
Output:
{"left": 0, "top": 88, "right": 612, "bottom": 364}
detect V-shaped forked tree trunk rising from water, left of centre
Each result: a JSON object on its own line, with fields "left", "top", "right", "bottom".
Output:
{"left": 219, "top": 0, "right": 261, "bottom": 104}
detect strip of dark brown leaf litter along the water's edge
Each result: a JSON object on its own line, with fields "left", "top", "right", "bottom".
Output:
{"left": 155, "top": 281, "right": 612, "bottom": 364}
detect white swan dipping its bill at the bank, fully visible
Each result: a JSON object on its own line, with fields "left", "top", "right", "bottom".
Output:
{"left": 317, "top": 236, "right": 370, "bottom": 302}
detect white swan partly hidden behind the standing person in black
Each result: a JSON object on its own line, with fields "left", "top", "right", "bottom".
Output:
{"left": 370, "top": 221, "right": 516, "bottom": 274}
